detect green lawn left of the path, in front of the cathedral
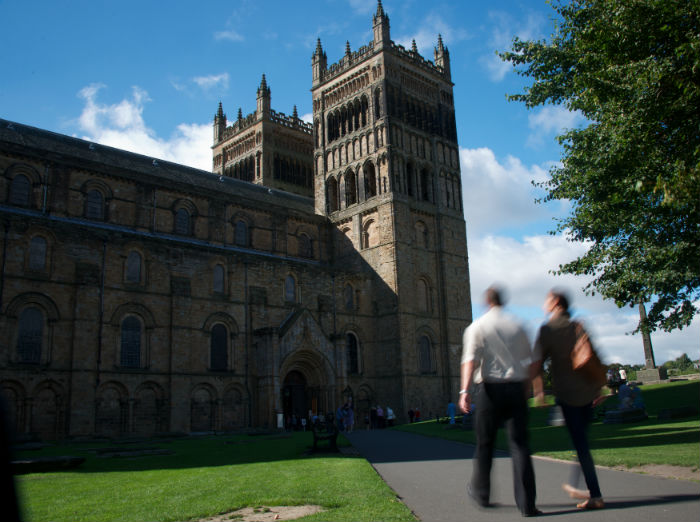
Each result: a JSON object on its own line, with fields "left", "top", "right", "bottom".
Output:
{"left": 16, "top": 433, "right": 415, "bottom": 522}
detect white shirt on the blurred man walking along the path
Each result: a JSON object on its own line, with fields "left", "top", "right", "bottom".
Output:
{"left": 462, "top": 306, "right": 532, "bottom": 383}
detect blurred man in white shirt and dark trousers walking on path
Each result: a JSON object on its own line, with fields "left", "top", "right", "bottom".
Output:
{"left": 459, "top": 286, "right": 542, "bottom": 517}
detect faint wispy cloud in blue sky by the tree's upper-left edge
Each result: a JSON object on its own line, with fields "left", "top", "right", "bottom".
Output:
{"left": 479, "top": 11, "right": 546, "bottom": 82}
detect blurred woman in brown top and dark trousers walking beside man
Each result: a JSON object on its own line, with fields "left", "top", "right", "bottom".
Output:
{"left": 533, "top": 290, "right": 605, "bottom": 509}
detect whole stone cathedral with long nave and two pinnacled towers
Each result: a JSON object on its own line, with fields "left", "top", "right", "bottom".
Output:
{"left": 0, "top": 1, "right": 471, "bottom": 439}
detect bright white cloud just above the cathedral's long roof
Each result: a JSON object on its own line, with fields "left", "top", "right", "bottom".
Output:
{"left": 77, "top": 84, "right": 211, "bottom": 170}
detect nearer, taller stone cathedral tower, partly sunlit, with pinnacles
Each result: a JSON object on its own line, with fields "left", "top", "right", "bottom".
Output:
{"left": 312, "top": 0, "right": 471, "bottom": 416}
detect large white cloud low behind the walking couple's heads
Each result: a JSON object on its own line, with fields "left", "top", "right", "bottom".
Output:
{"left": 469, "top": 235, "right": 700, "bottom": 364}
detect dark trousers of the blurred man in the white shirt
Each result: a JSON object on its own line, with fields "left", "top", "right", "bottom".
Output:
{"left": 472, "top": 382, "right": 536, "bottom": 513}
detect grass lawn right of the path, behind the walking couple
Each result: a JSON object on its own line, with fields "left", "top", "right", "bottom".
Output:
{"left": 398, "top": 381, "right": 700, "bottom": 469}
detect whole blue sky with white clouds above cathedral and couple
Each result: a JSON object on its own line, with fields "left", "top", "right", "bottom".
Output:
{"left": 0, "top": 0, "right": 700, "bottom": 363}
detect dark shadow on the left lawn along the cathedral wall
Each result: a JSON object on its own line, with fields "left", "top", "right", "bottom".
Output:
{"left": 14, "top": 432, "right": 359, "bottom": 473}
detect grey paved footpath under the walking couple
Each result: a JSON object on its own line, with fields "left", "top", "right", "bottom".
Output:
{"left": 346, "top": 430, "right": 700, "bottom": 522}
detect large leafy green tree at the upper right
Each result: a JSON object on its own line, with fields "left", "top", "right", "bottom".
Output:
{"left": 500, "top": 0, "right": 700, "bottom": 331}
